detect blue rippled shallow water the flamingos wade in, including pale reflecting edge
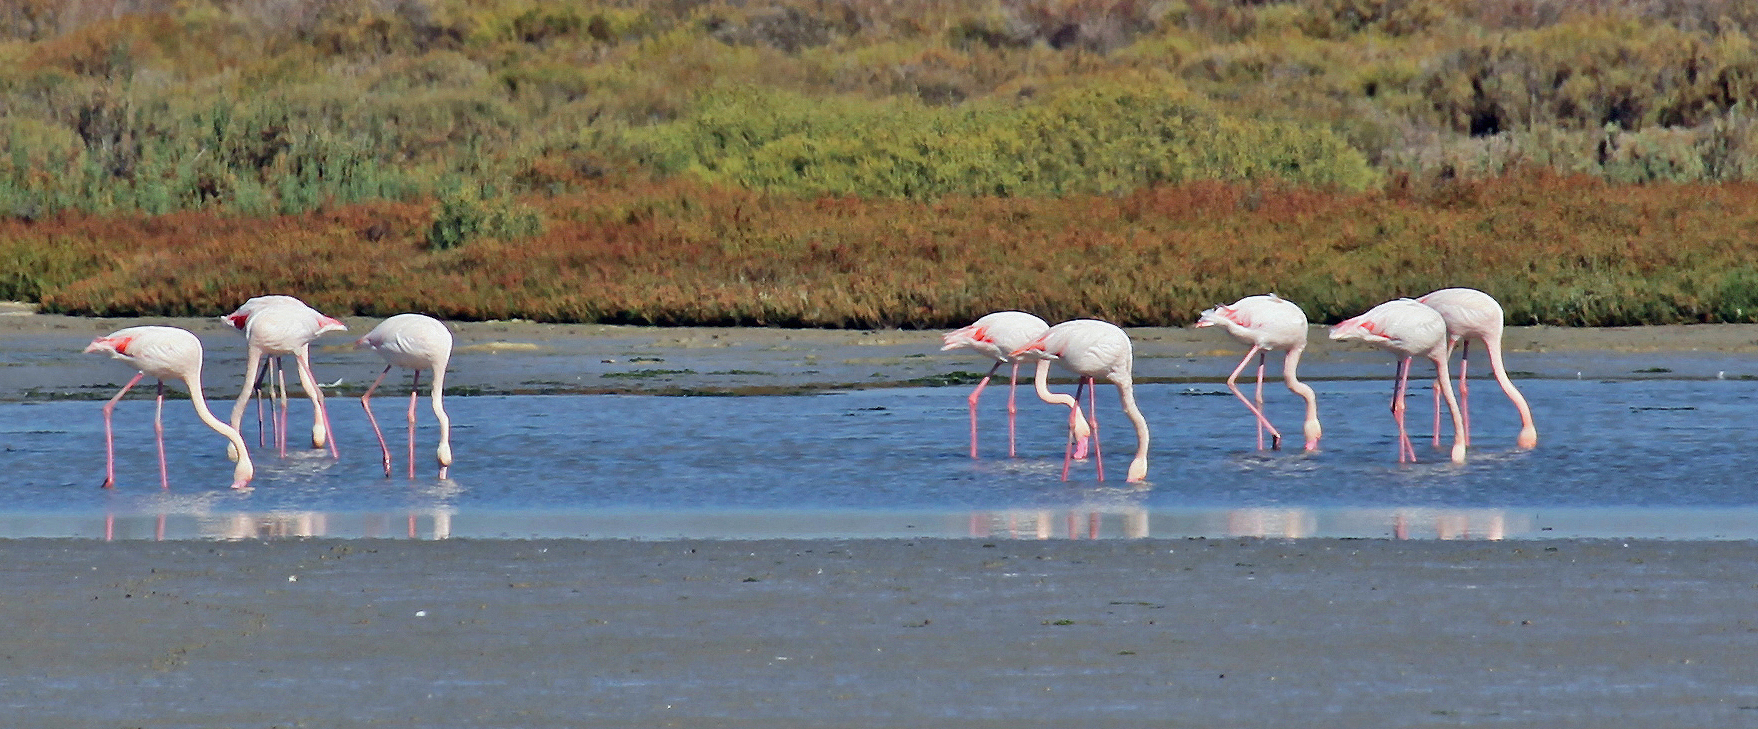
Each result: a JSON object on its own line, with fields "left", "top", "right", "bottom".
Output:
{"left": 0, "top": 379, "right": 1758, "bottom": 539}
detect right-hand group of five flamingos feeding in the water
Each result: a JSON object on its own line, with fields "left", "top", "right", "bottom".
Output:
{"left": 941, "top": 288, "right": 1538, "bottom": 481}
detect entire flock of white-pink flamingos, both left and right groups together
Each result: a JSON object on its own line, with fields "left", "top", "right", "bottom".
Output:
{"left": 84, "top": 288, "right": 1538, "bottom": 488}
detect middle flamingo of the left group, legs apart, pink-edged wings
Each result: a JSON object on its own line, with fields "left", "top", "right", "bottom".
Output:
{"left": 223, "top": 297, "right": 348, "bottom": 457}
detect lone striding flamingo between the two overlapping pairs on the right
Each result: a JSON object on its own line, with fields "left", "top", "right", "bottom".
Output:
{"left": 1197, "top": 293, "right": 1324, "bottom": 450}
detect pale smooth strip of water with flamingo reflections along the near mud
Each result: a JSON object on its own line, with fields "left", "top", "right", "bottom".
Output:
{"left": 13, "top": 504, "right": 1758, "bottom": 541}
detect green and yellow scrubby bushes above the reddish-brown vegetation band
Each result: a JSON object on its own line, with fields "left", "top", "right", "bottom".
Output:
{"left": 0, "top": 0, "right": 1758, "bottom": 218}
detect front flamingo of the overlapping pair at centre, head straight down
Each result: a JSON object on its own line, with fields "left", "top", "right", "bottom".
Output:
{"left": 1011, "top": 320, "right": 1148, "bottom": 483}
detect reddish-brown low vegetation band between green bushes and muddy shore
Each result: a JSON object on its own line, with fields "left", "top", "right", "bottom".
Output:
{"left": 13, "top": 174, "right": 1758, "bottom": 328}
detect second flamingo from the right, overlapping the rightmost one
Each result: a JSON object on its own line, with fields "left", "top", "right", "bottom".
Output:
{"left": 1331, "top": 299, "right": 1464, "bottom": 464}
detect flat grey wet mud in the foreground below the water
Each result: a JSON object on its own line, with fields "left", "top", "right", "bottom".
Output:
{"left": 0, "top": 539, "right": 1758, "bottom": 727}
